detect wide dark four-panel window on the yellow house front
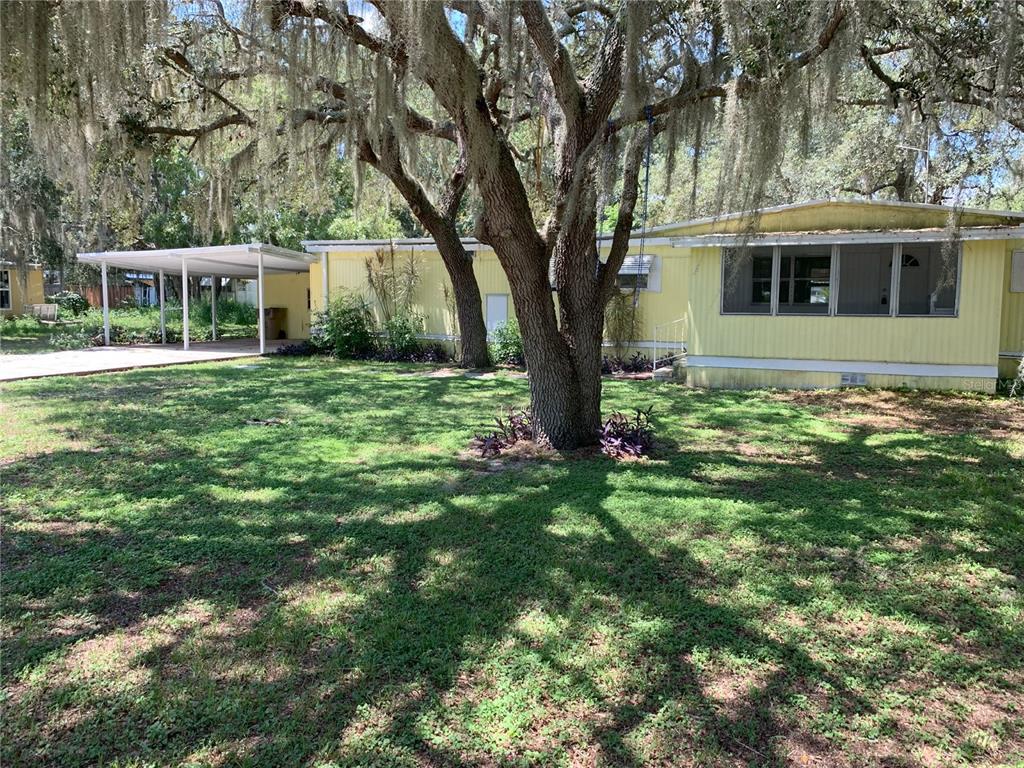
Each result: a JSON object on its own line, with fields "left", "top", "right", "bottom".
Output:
{"left": 722, "top": 243, "right": 961, "bottom": 316}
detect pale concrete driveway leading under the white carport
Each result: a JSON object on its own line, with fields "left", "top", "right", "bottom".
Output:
{"left": 0, "top": 339, "right": 295, "bottom": 381}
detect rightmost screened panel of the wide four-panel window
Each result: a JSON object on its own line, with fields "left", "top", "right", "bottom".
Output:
{"left": 899, "top": 243, "right": 959, "bottom": 315}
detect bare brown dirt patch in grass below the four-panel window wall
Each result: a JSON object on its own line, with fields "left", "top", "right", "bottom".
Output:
{"left": 769, "top": 389, "right": 1024, "bottom": 439}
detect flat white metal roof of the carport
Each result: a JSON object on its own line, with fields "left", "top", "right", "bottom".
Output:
{"left": 78, "top": 243, "right": 316, "bottom": 278}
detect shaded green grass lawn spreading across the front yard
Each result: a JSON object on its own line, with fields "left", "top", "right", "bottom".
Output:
{"left": 0, "top": 358, "right": 1024, "bottom": 766}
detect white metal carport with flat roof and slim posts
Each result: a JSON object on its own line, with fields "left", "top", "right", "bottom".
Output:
{"left": 78, "top": 243, "right": 316, "bottom": 354}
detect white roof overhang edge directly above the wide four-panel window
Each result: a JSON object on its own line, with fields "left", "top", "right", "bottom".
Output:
{"left": 669, "top": 226, "right": 1024, "bottom": 248}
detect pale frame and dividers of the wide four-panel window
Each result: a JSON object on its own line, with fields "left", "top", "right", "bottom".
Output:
{"left": 718, "top": 241, "right": 964, "bottom": 317}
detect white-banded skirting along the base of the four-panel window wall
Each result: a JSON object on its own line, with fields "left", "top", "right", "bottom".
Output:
{"left": 687, "top": 354, "right": 998, "bottom": 392}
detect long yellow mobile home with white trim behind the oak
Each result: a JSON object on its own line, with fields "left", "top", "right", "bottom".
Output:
{"left": 303, "top": 200, "right": 1024, "bottom": 392}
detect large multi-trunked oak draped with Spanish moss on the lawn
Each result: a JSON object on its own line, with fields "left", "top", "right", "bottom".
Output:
{"left": 3, "top": 0, "right": 1024, "bottom": 447}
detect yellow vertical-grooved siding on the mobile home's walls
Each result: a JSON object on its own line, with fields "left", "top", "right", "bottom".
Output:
{"left": 309, "top": 201, "right": 1024, "bottom": 391}
